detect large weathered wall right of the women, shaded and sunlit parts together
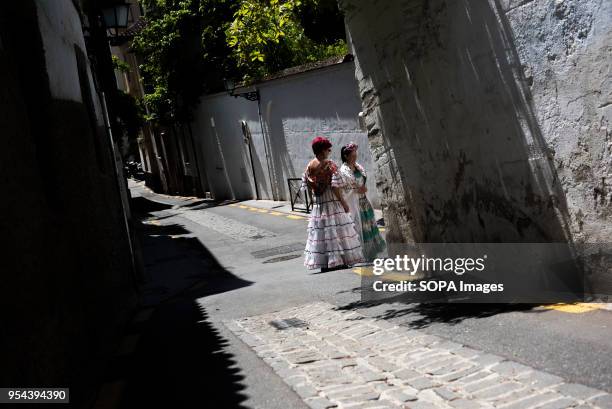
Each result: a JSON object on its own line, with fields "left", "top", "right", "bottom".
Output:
{"left": 340, "top": 0, "right": 612, "bottom": 242}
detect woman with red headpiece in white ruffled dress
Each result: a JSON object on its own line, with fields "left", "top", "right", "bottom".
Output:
{"left": 303, "top": 136, "right": 364, "bottom": 271}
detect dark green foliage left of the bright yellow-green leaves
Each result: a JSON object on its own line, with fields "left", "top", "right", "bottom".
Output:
{"left": 133, "top": 0, "right": 236, "bottom": 122}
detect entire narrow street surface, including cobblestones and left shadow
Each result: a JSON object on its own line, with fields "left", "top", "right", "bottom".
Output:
{"left": 97, "top": 182, "right": 612, "bottom": 408}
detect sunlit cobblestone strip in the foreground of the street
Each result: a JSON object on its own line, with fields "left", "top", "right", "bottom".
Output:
{"left": 225, "top": 302, "right": 612, "bottom": 409}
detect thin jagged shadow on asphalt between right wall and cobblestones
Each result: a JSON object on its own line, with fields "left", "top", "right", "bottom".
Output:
{"left": 337, "top": 301, "right": 542, "bottom": 329}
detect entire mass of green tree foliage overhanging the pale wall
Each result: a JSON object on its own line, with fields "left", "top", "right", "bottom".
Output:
{"left": 133, "top": 0, "right": 346, "bottom": 122}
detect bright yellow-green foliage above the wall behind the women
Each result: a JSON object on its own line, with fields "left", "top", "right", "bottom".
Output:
{"left": 227, "top": 0, "right": 347, "bottom": 80}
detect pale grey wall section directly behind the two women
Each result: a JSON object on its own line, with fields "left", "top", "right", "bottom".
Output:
{"left": 260, "top": 62, "right": 379, "bottom": 206}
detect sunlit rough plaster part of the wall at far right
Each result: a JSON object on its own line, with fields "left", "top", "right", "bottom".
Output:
{"left": 504, "top": 0, "right": 612, "bottom": 243}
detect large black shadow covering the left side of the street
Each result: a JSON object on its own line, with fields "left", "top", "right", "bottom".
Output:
{"left": 99, "top": 194, "right": 251, "bottom": 409}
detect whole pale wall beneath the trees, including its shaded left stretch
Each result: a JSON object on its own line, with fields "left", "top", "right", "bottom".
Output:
{"left": 193, "top": 62, "right": 379, "bottom": 206}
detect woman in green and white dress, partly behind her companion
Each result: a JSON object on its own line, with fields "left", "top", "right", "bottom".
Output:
{"left": 340, "top": 143, "right": 385, "bottom": 262}
